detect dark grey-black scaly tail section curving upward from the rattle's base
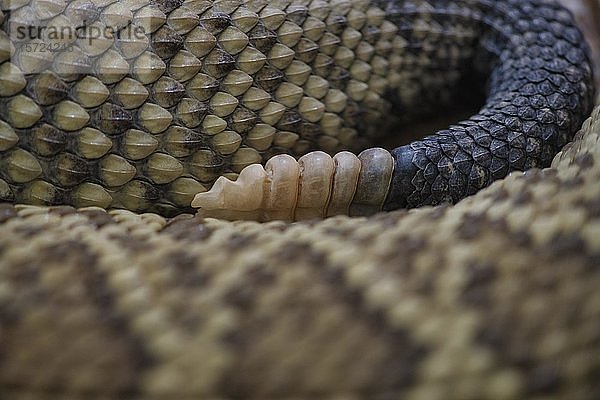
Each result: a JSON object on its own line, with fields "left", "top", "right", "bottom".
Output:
{"left": 385, "top": 1, "right": 593, "bottom": 209}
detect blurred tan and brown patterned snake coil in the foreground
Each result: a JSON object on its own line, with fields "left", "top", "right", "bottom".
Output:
{"left": 0, "top": 107, "right": 600, "bottom": 400}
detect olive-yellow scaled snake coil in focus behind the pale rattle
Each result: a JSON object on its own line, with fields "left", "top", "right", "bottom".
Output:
{"left": 0, "top": 0, "right": 474, "bottom": 214}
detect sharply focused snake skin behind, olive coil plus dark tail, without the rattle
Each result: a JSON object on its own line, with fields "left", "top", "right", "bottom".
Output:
{"left": 0, "top": 0, "right": 593, "bottom": 215}
